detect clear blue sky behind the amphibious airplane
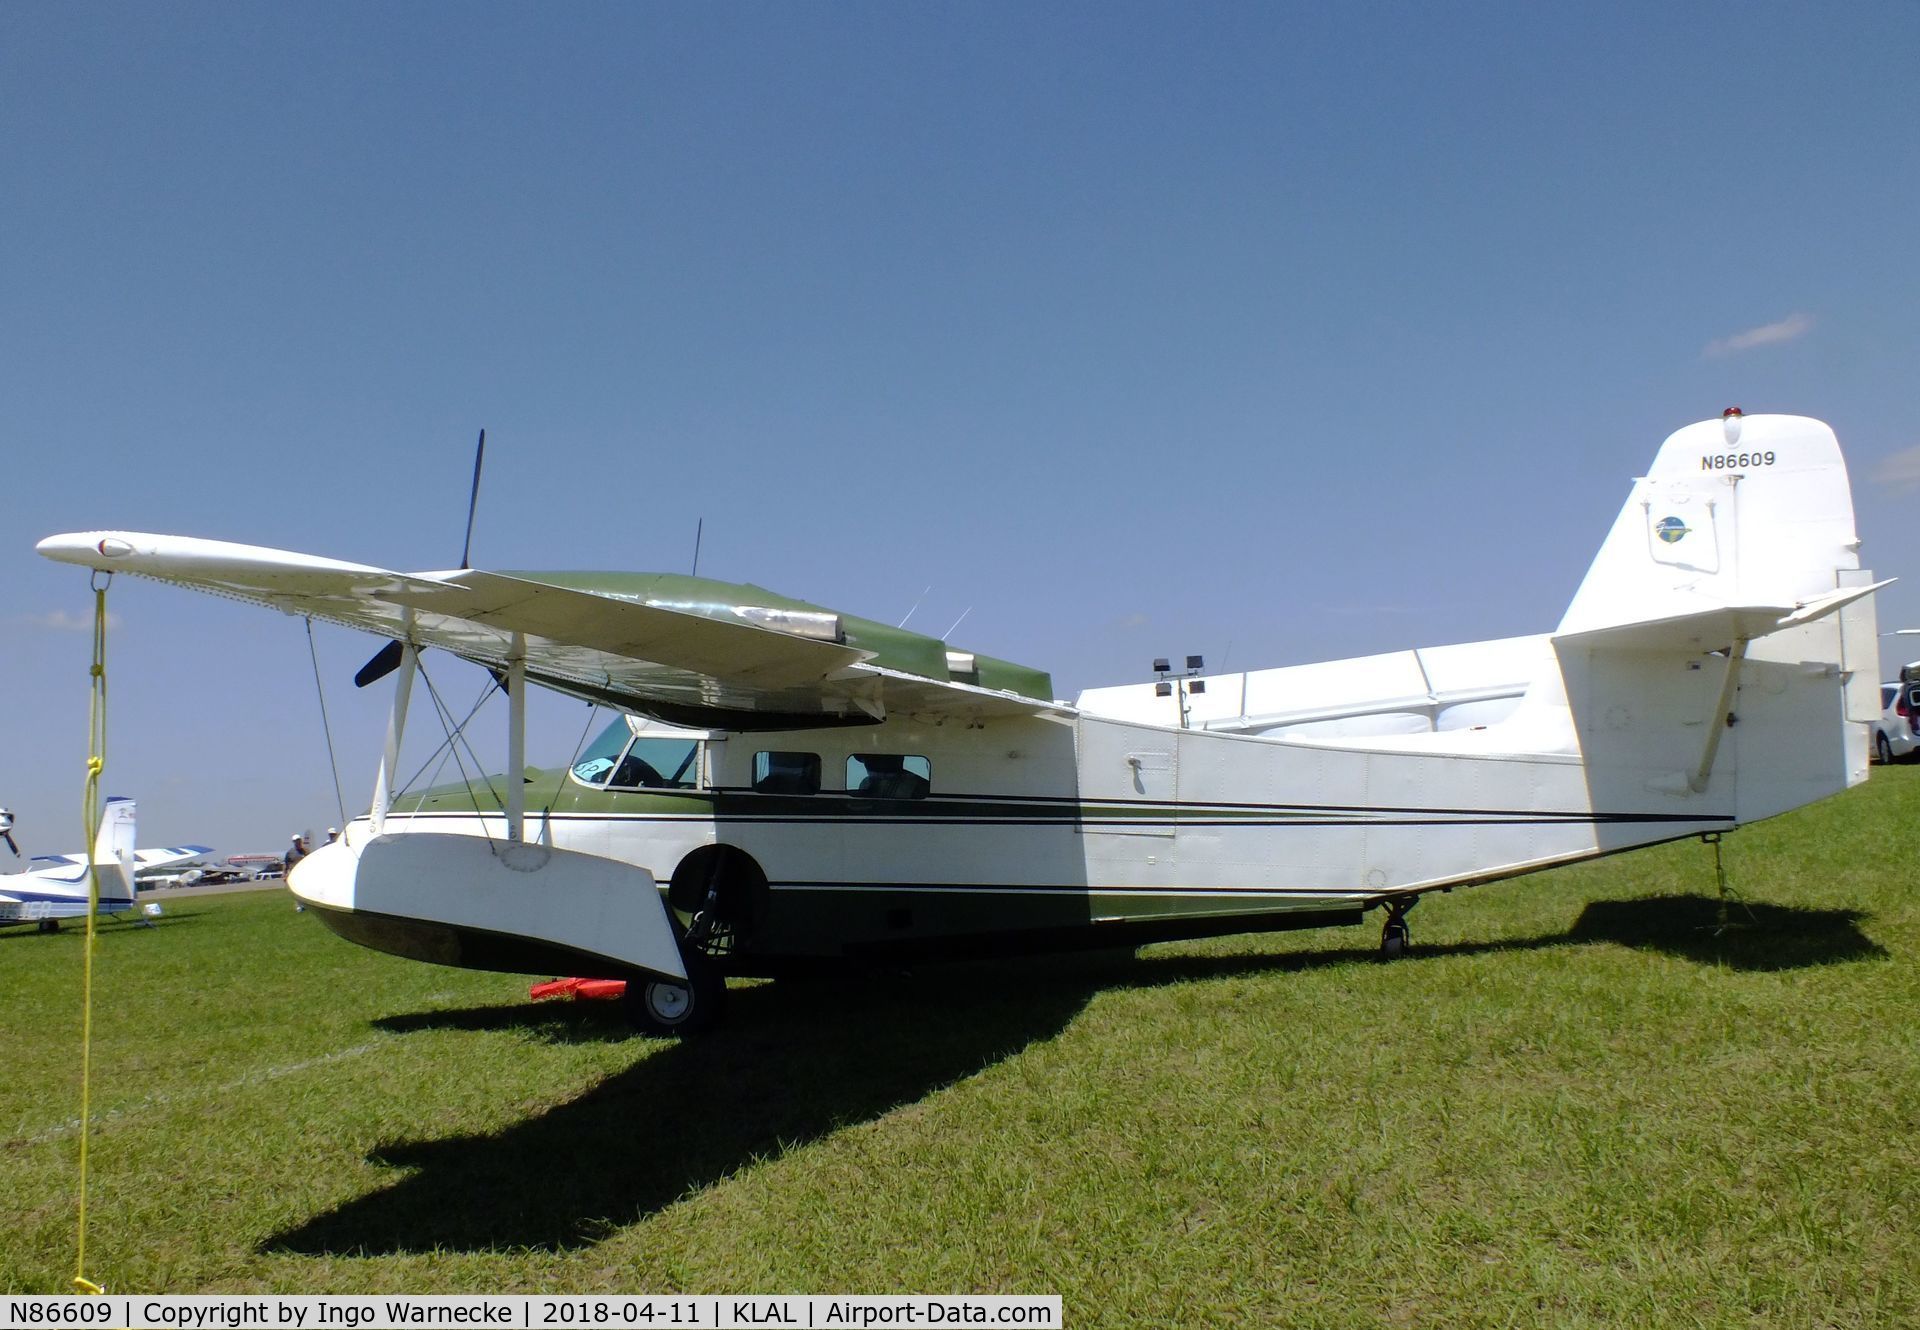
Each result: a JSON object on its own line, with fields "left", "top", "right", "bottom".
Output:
{"left": 0, "top": 0, "right": 1920, "bottom": 850}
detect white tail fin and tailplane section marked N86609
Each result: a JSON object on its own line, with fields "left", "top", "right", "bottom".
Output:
{"left": 1528, "top": 411, "right": 1878, "bottom": 821}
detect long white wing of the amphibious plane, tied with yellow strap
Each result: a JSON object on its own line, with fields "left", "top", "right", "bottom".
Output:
{"left": 38, "top": 532, "right": 1068, "bottom": 729}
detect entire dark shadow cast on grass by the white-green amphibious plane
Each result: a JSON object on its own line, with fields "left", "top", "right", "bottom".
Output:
{"left": 261, "top": 894, "right": 1887, "bottom": 1255}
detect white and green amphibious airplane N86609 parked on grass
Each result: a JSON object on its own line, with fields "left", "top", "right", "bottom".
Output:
{"left": 38, "top": 411, "right": 1884, "bottom": 1031}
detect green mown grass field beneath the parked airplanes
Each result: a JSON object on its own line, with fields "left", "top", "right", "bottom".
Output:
{"left": 0, "top": 768, "right": 1920, "bottom": 1326}
